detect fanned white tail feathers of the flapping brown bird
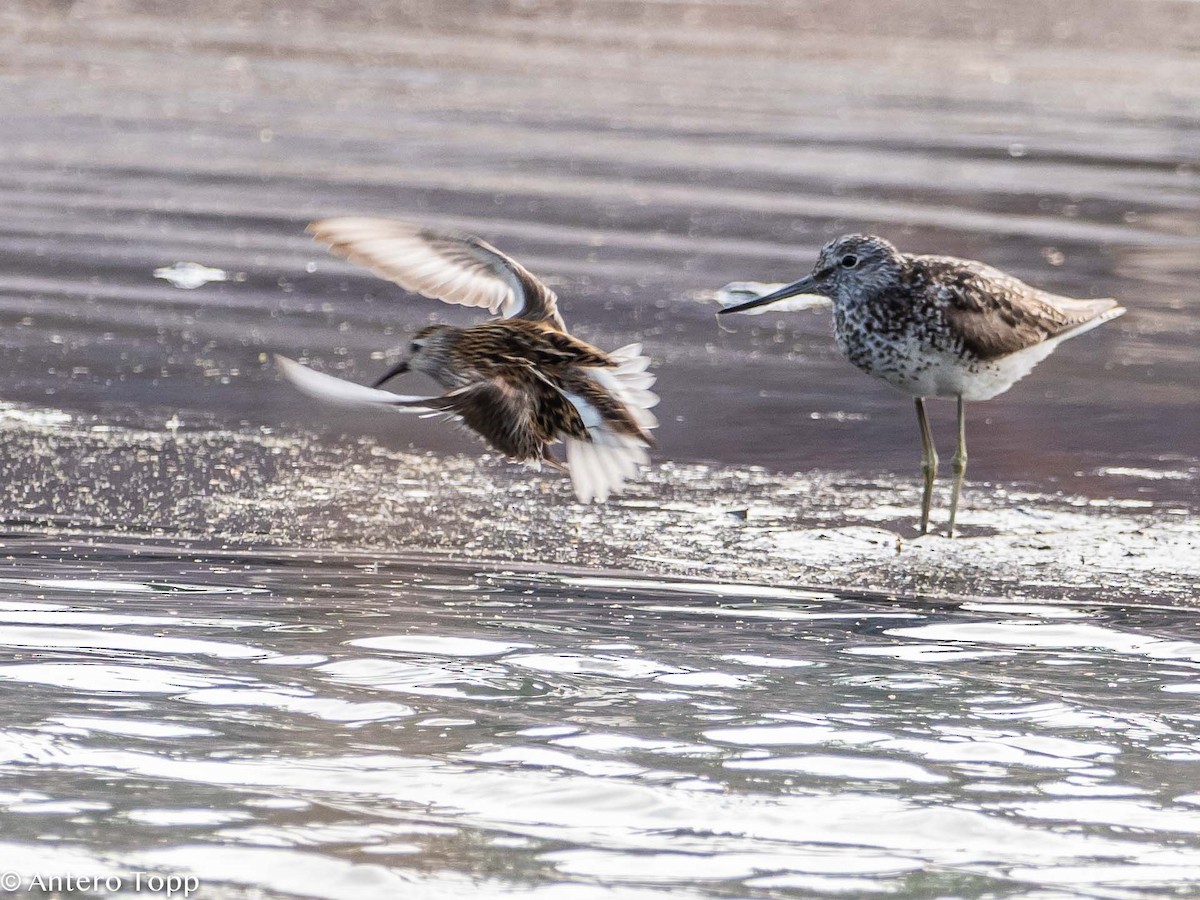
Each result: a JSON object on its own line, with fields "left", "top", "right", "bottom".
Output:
{"left": 564, "top": 343, "right": 659, "bottom": 503}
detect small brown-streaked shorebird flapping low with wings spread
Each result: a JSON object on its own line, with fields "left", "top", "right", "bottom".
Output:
{"left": 276, "top": 218, "right": 658, "bottom": 503}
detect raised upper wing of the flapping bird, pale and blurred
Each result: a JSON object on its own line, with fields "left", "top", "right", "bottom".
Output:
{"left": 307, "top": 216, "right": 565, "bottom": 330}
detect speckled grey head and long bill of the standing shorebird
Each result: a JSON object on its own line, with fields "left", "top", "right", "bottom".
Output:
{"left": 721, "top": 234, "right": 904, "bottom": 313}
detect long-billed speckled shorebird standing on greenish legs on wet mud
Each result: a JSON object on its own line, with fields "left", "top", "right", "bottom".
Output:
{"left": 721, "top": 234, "right": 1124, "bottom": 536}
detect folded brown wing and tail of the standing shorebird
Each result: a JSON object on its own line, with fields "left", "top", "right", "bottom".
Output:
{"left": 919, "top": 257, "right": 1124, "bottom": 360}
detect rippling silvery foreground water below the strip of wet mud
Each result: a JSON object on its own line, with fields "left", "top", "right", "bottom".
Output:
{"left": 0, "top": 557, "right": 1200, "bottom": 898}
